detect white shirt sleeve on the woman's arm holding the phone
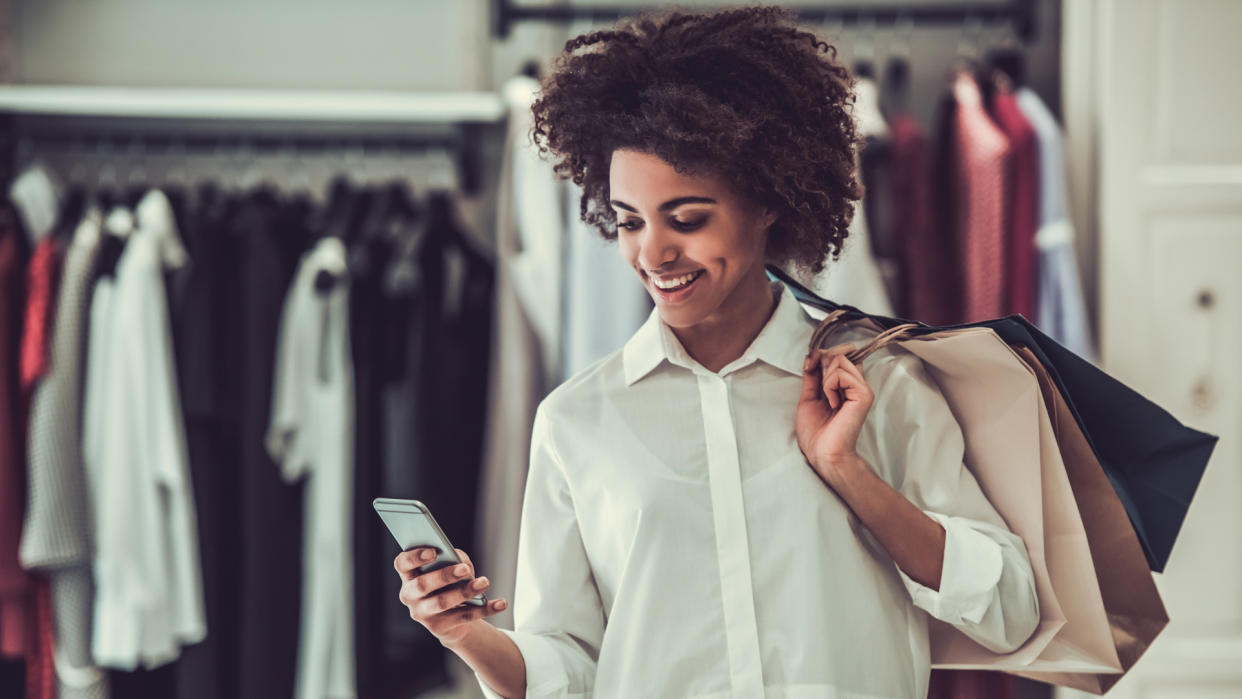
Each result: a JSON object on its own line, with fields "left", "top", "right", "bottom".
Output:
{"left": 476, "top": 404, "right": 605, "bottom": 699}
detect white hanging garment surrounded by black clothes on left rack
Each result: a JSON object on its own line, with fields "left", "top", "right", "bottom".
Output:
{"left": 266, "top": 236, "right": 356, "bottom": 699}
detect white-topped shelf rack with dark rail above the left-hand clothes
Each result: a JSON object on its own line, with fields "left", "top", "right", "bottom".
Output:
{"left": 0, "top": 86, "right": 505, "bottom": 195}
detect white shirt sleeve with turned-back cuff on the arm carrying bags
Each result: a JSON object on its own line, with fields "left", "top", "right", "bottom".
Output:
{"left": 868, "top": 351, "right": 1040, "bottom": 653}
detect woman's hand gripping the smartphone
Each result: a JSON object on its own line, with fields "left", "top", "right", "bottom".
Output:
{"left": 392, "top": 546, "right": 507, "bottom": 646}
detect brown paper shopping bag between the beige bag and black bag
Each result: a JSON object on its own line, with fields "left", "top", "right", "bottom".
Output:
{"left": 1012, "top": 346, "right": 1169, "bottom": 694}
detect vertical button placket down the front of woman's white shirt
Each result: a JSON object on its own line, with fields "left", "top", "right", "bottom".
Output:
{"left": 696, "top": 372, "right": 764, "bottom": 697}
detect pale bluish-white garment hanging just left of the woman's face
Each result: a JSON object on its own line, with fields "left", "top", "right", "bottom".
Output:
{"left": 560, "top": 180, "right": 652, "bottom": 380}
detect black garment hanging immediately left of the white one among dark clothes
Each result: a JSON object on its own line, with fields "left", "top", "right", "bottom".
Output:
{"left": 233, "top": 187, "right": 309, "bottom": 699}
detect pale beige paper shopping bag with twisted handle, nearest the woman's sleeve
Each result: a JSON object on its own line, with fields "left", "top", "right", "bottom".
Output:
{"left": 811, "top": 312, "right": 1122, "bottom": 679}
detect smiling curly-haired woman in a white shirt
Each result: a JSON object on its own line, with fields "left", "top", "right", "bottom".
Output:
{"left": 395, "top": 7, "right": 1038, "bottom": 699}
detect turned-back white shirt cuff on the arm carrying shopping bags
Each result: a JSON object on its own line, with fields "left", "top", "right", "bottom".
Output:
{"left": 893, "top": 510, "right": 1004, "bottom": 626}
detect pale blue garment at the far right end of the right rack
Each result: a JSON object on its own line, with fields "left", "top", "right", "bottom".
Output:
{"left": 1016, "top": 87, "right": 1098, "bottom": 364}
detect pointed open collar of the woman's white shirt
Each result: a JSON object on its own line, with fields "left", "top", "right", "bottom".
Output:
{"left": 621, "top": 282, "right": 814, "bottom": 385}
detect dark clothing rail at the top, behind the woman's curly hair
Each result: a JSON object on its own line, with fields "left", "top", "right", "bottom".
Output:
{"left": 492, "top": 0, "right": 1037, "bottom": 42}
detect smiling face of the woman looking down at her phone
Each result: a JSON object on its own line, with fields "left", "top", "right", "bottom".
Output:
{"left": 609, "top": 149, "right": 775, "bottom": 328}
